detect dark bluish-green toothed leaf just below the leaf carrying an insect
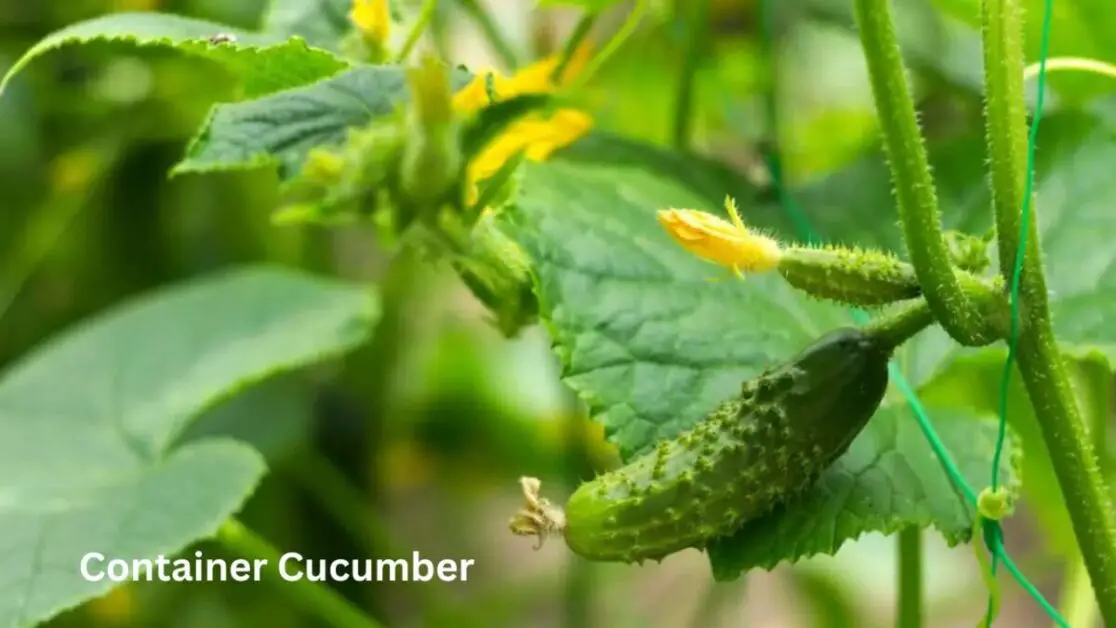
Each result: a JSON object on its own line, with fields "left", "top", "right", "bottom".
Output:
{"left": 172, "top": 66, "right": 469, "bottom": 180}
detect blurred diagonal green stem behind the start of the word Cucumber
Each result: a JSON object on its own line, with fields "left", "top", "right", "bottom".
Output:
{"left": 217, "top": 519, "right": 383, "bottom": 628}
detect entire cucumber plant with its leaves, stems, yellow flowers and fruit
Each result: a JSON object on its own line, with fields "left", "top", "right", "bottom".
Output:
{"left": 0, "top": 0, "right": 1116, "bottom": 627}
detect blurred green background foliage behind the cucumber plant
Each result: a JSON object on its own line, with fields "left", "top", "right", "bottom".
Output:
{"left": 0, "top": 0, "right": 1116, "bottom": 628}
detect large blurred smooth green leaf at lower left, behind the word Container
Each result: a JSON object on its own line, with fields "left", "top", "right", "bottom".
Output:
{"left": 0, "top": 268, "right": 378, "bottom": 627}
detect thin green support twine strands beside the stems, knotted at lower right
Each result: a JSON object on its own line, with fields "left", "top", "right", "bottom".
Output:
{"left": 760, "top": 0, "right": 1069, "bottom": 628}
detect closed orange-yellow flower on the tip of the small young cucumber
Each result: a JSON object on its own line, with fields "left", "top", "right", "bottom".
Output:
{"left": 657, "top": 197, "right": 782, "bottom": 278}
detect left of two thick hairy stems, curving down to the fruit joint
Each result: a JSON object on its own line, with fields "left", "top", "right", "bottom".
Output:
{"left": 853, "top": 0, "right": 997, "bottom": 346}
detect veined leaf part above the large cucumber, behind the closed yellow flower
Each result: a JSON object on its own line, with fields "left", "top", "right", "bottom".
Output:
{"left": 507, "top": 162, "right": 848, "bottom": 458}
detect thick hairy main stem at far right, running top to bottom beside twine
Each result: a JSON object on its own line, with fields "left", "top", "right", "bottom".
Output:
{"left": 981, "top": 0, "right": 1116, "bottom": 626}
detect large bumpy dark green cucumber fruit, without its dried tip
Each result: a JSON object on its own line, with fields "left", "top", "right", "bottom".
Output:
{"left": 564, "top": 329, "right": 891, "bottom": 562}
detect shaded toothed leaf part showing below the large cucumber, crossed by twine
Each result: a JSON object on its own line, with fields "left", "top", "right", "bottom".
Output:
{"left": 709, "top": 403, "right": 1022, "bottom": 580}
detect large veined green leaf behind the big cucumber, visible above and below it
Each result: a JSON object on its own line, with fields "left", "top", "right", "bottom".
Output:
{"left": 504, "top": 156, "right": 1018, "bottom": 578}
